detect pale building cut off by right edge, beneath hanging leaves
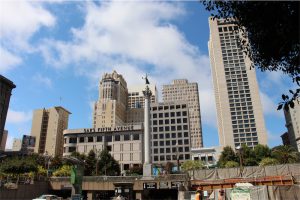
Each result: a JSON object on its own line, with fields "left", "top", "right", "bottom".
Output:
{"left": 284, "top": 101, "right": 300, "bottom": 152}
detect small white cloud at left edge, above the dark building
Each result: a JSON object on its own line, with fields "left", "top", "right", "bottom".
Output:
{"left": 0, "top": 47, "right": 22, "bottom": 73}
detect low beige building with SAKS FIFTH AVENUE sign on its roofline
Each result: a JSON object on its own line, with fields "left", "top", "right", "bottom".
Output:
{"left": 63, "top": 125, "right": 143, "bottom": 171}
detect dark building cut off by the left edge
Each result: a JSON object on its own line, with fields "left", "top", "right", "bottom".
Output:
{"left": 0, "top": 75, "right": 16, "bottom": 144}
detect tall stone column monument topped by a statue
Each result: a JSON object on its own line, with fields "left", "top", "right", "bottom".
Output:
{"left": 143, "top": 75, "right": 152, "bottom": 177}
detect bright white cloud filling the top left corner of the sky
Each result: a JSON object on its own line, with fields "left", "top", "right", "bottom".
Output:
{"left": 0, "top": 1, "right": 55, "bottom": 48}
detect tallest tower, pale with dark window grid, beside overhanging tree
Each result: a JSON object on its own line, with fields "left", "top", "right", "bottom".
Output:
{"left": 208, "top": 18, "right": 267, "bottom": 148}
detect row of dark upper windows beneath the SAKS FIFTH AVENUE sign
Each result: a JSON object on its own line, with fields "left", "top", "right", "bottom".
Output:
{"left": 65, "top": 134, "right": 140, "bottom": 144}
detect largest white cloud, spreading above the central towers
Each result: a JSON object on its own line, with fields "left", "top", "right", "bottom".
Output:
{"left": 40, "top": 1, "right": 215, "bottom": 124}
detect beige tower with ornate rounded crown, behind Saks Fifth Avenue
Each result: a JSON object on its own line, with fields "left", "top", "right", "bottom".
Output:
{"left": 93, "top": 71, "right": 128, "bottom": 128}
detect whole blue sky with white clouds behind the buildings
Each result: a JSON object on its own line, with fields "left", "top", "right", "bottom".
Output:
{"left": 0, "top": 1, "right": 294, "bottom": 148}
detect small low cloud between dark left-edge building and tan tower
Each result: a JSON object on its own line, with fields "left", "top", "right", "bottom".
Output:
{"left": 6, "top": 109, "right": 32, "bottom": 124}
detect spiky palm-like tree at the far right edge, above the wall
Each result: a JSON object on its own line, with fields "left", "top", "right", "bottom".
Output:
{"left": 271, "top": 145, "right": 300, "bottom": 164}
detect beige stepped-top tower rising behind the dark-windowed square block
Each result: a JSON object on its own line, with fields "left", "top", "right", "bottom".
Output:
{"left": 162, "top": 79, "right": 203, "bottom": 148}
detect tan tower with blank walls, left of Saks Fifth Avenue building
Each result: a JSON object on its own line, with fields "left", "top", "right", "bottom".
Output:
{"left": 31, "top": 106, "right": 71, "bottom": 156}
